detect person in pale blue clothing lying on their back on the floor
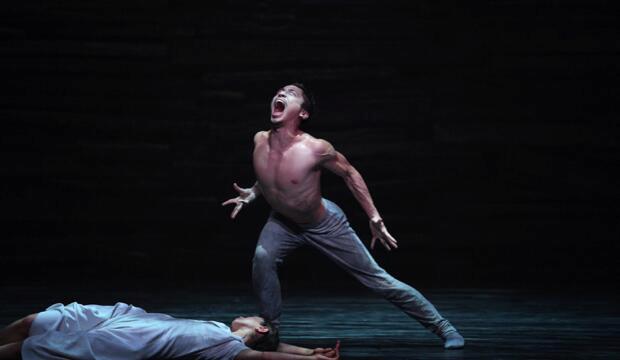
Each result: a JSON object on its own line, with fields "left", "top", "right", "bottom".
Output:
{"left": 0, "top": 302, "right": 339, "bottom": 360}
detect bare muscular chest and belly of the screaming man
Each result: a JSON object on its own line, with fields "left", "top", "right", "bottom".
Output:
{"left": 254, "top": 132, "right": 325, "bottom": 223}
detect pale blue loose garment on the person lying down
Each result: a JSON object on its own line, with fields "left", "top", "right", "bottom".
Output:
{"left": 22, "top": 303, "right": 247, "bottom": 360}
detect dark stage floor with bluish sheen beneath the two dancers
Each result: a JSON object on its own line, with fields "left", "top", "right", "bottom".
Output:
{"left": 0, "top": 284, "right": 620, "bottom": 360}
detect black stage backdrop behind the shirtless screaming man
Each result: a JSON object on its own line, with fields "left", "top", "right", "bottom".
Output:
{"left": 0, "top": 0, "right": 620, "bottom": 292}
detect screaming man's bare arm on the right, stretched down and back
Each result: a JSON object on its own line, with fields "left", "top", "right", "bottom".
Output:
{"left": 318, "top": 140, "right": 398, "bottom": 250}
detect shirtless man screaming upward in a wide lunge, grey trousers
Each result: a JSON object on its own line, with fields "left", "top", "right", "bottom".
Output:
{"left": 222, "top": 83, "right": 465, "bottom": 349}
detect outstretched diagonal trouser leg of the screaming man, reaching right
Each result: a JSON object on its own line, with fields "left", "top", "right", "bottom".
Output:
{"left": 304, "top": 202, "right": 456, "bottom": 336}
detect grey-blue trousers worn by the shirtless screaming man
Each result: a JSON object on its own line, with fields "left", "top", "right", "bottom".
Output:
{"left": 252, "top": 199, "right": 456, "bottom": 336}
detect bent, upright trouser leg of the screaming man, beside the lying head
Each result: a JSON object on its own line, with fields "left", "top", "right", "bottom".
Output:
{"left": 252, "top": 215, "right": 302, "bottom": 326}
